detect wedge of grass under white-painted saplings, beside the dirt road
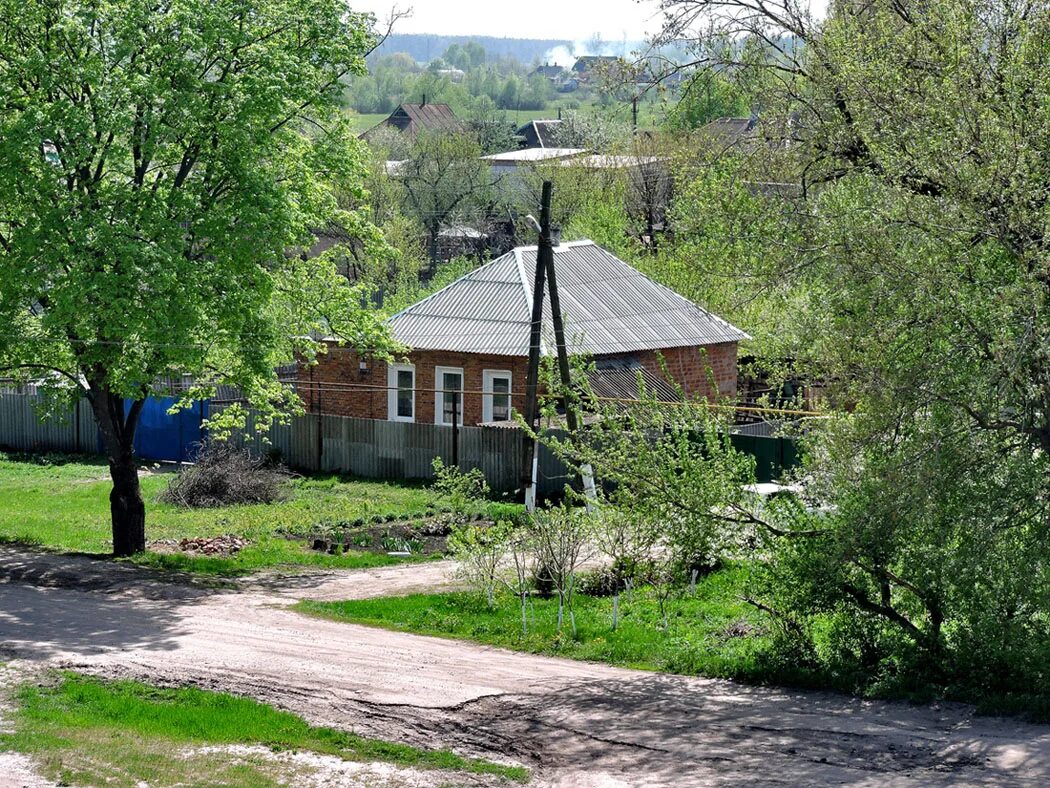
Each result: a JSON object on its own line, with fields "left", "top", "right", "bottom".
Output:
{"left": 296, "top": 565, "right": 793, "bottom": 681}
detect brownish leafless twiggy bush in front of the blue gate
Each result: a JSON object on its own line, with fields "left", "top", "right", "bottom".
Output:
{"left": 161, "top": 441, "right": 289, "bottom": 509}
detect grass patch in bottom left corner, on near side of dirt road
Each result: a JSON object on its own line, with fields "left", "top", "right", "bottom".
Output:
{"left": 0, "top": 672, "right": 528, "bottom": 786}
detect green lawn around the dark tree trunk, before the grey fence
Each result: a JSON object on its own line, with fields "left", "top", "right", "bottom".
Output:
{"left": 0, "top": 455, "right": 447, "bottom": 576}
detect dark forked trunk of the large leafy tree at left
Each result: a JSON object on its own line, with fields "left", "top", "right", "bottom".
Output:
{"left": 89, "top": 386, "right": 146, "bottom": 557}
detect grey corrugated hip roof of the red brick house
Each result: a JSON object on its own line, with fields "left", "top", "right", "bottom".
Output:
{"left": 387, "top": 241, "right": 750, "bottom": 356}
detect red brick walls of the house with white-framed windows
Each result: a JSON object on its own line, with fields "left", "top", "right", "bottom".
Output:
{"left": 299, "top": 343, "right": 737, "bottom": 424}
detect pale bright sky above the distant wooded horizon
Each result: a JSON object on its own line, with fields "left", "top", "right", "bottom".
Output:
{"left": 351, "top": 0, "right": 659, "bottom": 41}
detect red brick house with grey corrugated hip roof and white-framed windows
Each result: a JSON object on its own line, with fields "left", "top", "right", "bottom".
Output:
{"left": 299, "top": 241, "right": 748, "bottom": 424}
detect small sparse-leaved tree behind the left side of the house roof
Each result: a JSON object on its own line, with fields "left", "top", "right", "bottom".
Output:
{"left": 398, "top": 132, "right": 491, "bottom": 273}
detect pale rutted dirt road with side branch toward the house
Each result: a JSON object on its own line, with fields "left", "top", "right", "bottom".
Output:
{"left": 0, "top": 548, "right": 1050, "bottom": 787}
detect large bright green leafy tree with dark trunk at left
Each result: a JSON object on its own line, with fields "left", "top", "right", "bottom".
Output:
{"left": 0, "top": 0, "right": 394, "bottom": 556}
